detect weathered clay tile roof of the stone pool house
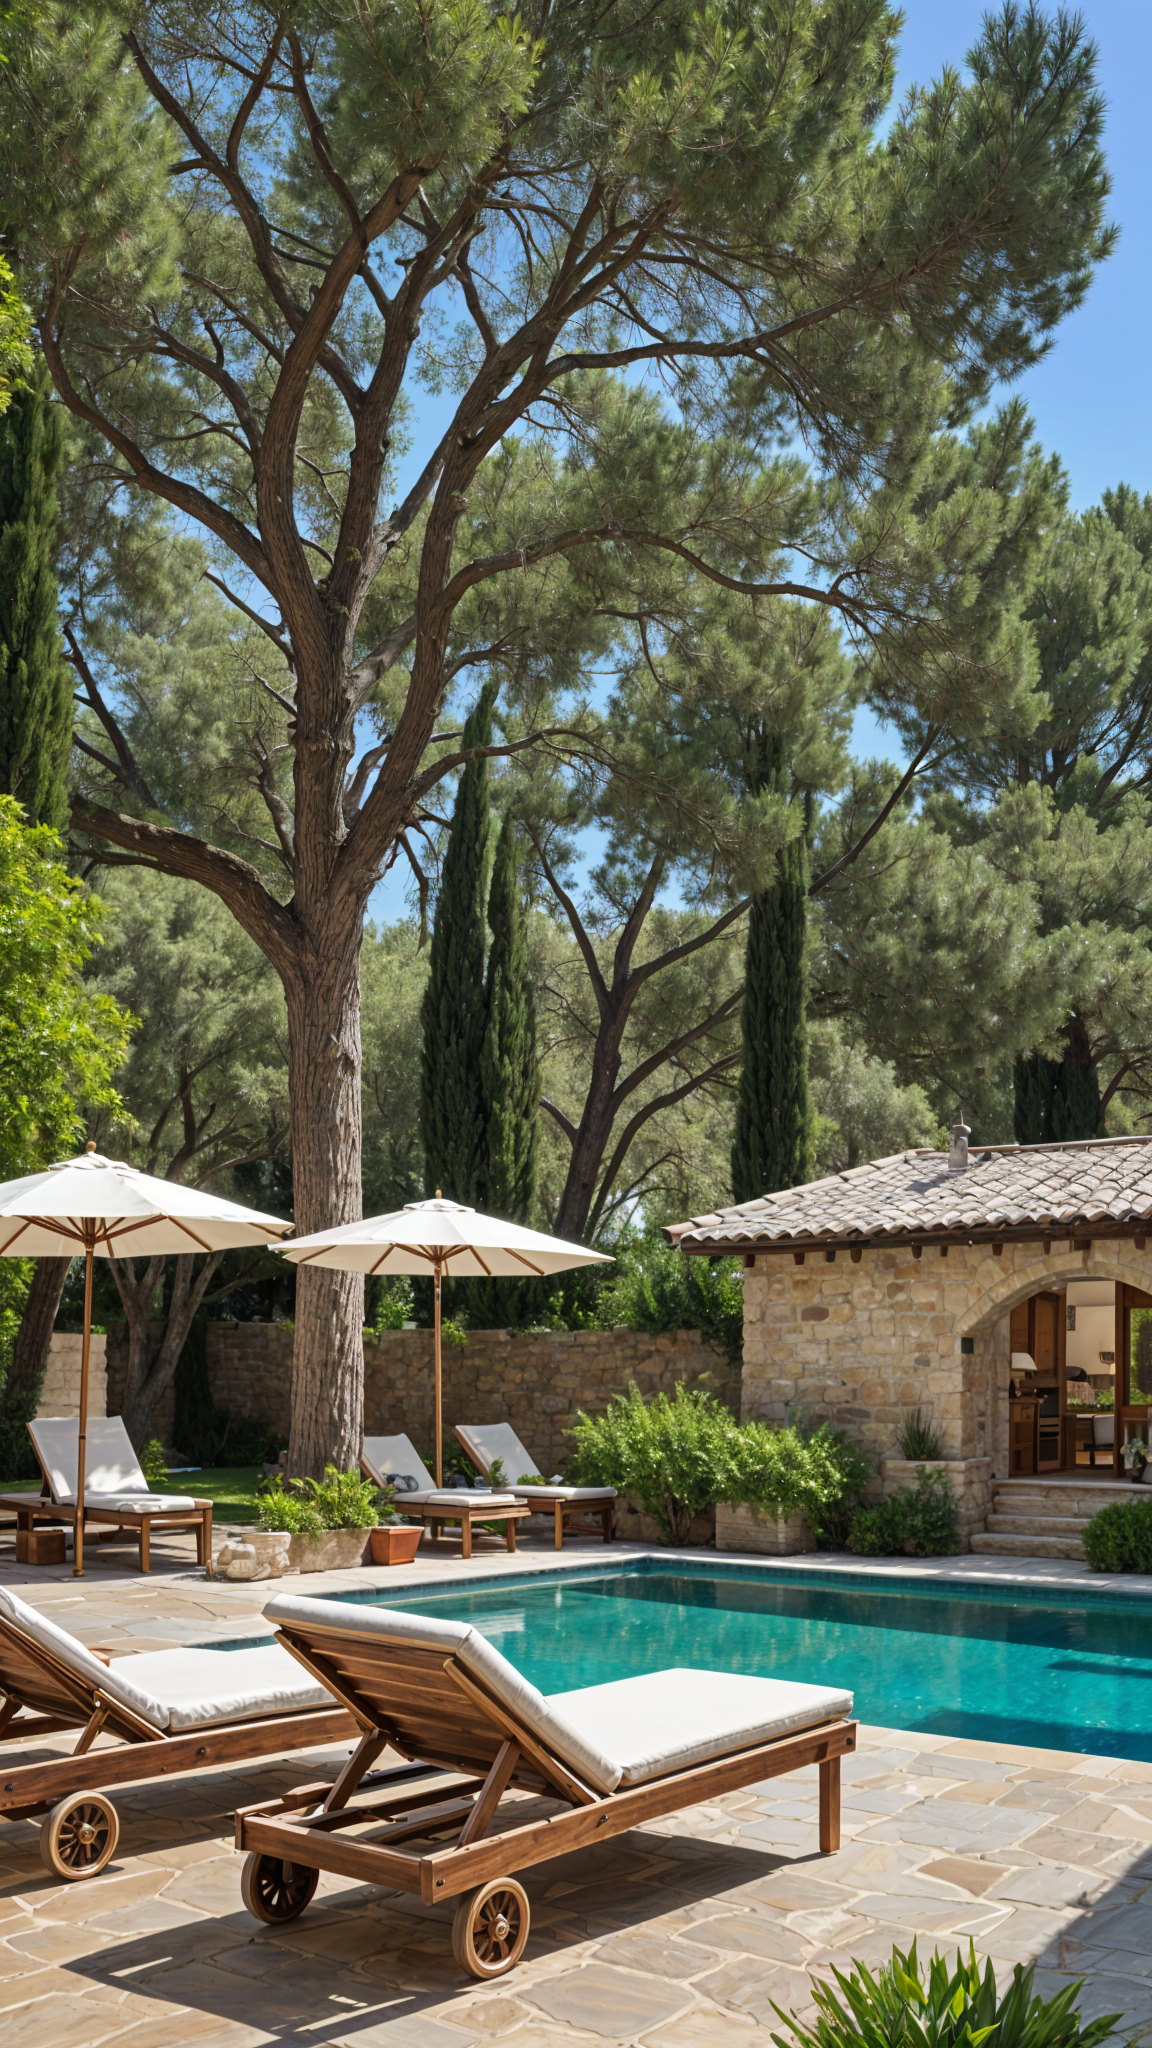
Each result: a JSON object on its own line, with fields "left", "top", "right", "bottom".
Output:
{"left": 666, "top": 1137, "right": 1152, "bottom": 1251}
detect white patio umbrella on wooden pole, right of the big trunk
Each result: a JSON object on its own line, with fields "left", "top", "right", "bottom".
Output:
{"left": 269, "top": 1188, "right": 611, "bottom": 1487}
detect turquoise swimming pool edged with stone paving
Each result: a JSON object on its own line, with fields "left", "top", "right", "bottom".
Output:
{"left": 326, "top": 1559, "right": 1152, "bottom": 1761}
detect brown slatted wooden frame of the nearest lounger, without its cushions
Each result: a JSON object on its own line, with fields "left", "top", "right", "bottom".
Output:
{"left": 236, "top": 1624, "right": 857, "bottom": 1974}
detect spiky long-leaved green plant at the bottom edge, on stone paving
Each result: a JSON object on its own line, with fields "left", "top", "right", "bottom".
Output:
{"left": 773, "top": 1942, "right": 1119, "bottom": 2048}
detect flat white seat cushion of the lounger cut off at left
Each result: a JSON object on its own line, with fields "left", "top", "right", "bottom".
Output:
{"left": 109, "top": 1642, "right": 334, "bottom": 1733}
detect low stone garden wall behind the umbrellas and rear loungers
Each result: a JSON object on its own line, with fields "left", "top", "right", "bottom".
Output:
{"left": 109, "top": 1323, "right": 740, "bottom": 1479}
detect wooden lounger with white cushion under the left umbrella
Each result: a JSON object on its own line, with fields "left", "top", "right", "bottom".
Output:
{"left": 2, "top": 1415, "right": 211, "bottom": 1579}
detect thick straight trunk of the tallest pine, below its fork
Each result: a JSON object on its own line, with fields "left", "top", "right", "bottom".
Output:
{"left": 282, "top": 942, "right": 365, "bottom": 1479}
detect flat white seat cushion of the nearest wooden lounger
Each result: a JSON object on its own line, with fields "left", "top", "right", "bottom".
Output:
{"left": 547, "top": 1667, "right": 853, "bottom": 1786}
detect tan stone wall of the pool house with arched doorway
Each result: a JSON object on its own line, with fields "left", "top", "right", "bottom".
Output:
{"left": 742, "top": 1237, "right": 1152, "bottom": 1489}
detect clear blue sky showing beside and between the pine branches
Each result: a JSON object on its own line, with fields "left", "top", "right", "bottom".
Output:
{"left": 371, "top": 0, "right": 1152, "bottom": 920}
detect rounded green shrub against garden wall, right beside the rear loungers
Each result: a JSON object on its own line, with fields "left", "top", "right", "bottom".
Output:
{"left": 566, "top": 1380, "right": 736, "bottom": 1542}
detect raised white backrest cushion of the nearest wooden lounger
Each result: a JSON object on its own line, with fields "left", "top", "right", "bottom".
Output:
{"left": 264, "top": 1593, "right": 619, "bottom": 1792}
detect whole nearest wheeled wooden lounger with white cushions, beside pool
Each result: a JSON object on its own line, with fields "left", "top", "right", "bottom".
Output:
{"left": 236, "top": 1595, "right": 857, "bottom": 1978}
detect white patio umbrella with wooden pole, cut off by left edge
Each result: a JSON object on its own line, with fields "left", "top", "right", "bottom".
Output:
{"left": 0, "top": 1143, "right": 291, "bottom": 1579}
